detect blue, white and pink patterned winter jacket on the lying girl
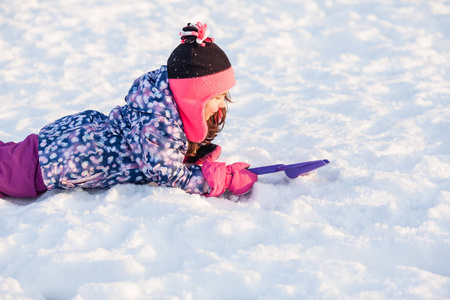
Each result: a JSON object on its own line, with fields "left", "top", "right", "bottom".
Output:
{"left": 39, "top": 66, "right": 204, "bottom": 193}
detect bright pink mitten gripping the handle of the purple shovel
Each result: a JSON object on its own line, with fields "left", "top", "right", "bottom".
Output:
{"left": 202, "top": 161, "right": 258, "bottom": 197}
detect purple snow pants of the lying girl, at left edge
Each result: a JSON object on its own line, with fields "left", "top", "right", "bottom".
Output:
{"left": 0, "top": 134, "right": 47, "bottom": 198}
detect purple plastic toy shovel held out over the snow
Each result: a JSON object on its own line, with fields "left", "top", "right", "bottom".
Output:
{"left": 248, "top": 159, "right": 330, "bottom": 178}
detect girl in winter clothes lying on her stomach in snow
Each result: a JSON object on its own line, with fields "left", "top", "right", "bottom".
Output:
{"left": 0, "top": 23, "right": 257, "bottom": 198}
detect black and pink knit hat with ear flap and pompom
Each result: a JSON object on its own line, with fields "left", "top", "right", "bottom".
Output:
{"left": 167, "top": 22, "right": 236, "bottom": 143}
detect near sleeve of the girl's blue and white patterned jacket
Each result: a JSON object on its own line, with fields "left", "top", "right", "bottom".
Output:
{"left": 126, "top": 114, "right": 204, "bottom": 194}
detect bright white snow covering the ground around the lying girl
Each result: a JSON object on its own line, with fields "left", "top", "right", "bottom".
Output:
{"left": 0, "top": 0, "right": 450, "bottom": 300}
